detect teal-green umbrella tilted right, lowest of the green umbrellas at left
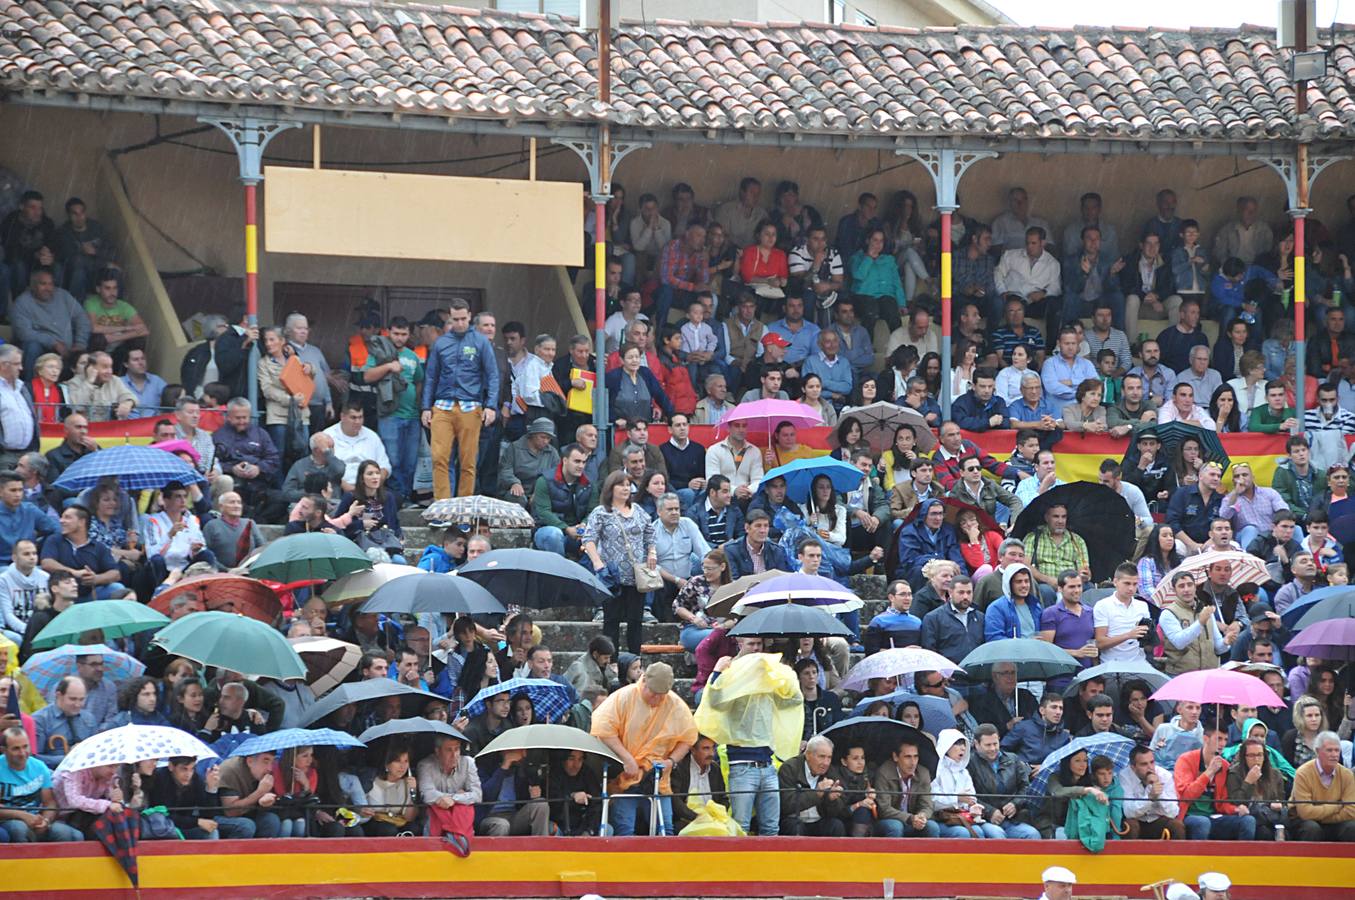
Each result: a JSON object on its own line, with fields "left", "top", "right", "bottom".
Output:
{"left": 152, "top": 613, "right": 306, "bottom": 680}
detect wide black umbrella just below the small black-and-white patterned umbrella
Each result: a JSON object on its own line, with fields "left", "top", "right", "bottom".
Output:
{"left": 457, "top": 550, "right": 611, "bottom": 610}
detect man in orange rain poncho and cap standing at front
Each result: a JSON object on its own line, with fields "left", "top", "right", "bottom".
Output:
{"left": 592, "top": 661, "right": 698, "bottom": 836}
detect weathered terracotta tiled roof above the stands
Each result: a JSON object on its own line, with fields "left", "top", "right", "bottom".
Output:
{"left": 0, "top": 0, "right": 1355, "bottom": 141}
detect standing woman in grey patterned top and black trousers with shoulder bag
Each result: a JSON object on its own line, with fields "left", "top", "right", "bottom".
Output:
{"left": 583, "top": 472, "right": 659, "bottom": 655}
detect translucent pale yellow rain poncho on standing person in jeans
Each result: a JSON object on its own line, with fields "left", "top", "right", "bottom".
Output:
{"left": 696, "top": 653, "right": 805, "bottom": 760}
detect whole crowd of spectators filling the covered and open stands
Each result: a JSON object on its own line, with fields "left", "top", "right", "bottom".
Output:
{"left": 0, "top": 179, "right": 1355, "bottom": 853}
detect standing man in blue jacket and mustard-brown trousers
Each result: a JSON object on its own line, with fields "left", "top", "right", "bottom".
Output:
{"left": 420, "top": 297, "right": 499, "bottom": 500}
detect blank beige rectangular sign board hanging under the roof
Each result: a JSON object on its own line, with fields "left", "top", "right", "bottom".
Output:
{"left": 263, "top": 165, "right": 584, "bottom": 266}
